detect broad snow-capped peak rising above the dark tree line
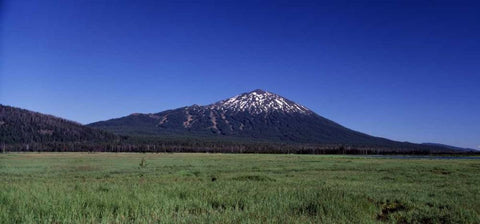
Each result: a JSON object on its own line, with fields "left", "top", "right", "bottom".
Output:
{"left": 88, "top": 89, "right": 414, "bottom": 147}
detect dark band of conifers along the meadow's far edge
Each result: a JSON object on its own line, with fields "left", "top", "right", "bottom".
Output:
{"left": 2, "top": 137, "right": 478, "bottom": 155}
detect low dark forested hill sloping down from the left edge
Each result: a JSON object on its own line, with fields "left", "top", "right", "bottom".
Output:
{"left": 0, "top": 104, "right": 117, "bottom": 144}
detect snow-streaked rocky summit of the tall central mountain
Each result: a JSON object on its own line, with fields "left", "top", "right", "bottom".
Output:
{"left": 208, "top": 89, "right": 312, "bottom": 114}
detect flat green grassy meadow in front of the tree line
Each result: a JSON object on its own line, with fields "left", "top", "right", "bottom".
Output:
{"left": 0, "top": 153, "right": 480, "bottom": 223}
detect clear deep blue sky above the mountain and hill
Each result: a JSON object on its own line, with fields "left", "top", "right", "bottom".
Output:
{"left": 0, "top": 0, "right": 480, "bottom": 148}
